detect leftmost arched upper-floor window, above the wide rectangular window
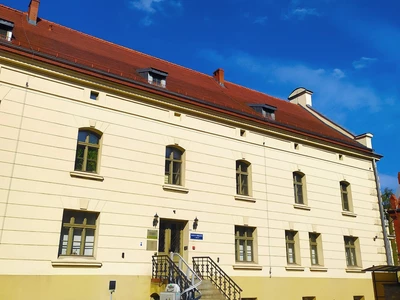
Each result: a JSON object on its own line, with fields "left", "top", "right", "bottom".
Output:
{"left": 75, "top": 129, "right": 101, "bottom": 173}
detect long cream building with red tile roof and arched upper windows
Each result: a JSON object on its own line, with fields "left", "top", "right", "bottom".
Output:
{"left": 0, "top": 0, "right": 387, "bottom": 300}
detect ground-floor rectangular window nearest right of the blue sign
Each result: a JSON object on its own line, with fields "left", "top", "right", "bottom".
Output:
{"left": 235, "top": 226, "right": 255, "bottom": 262}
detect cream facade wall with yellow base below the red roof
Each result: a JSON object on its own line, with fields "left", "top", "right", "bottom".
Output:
{"left": 0, "top": 53, "right": 386, "bottom": 300}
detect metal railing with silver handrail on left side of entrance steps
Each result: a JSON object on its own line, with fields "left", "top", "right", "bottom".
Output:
{"left": 152, "top": 254, "right": 201, "bottom": 300}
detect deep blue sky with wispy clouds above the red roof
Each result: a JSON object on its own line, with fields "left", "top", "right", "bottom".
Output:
{"left": 2, "top": 0, "right": 400, "bottom": 190}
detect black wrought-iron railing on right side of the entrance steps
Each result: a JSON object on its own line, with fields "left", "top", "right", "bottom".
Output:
{"left": 192, "top": 256, "right": 242, "bottom": 300}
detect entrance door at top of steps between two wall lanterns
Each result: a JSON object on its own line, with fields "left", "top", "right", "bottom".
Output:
{"left": 158, "top": 219, "right": 187, "bottom": 256}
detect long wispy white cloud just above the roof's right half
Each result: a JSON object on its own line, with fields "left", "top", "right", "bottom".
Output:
{"left": 200, "top": 49, "right": 383, "bottom": 112}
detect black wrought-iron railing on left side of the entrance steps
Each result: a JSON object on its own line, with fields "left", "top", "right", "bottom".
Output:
{"left": 151, "top": 255, "right": 201, "bottom": 300}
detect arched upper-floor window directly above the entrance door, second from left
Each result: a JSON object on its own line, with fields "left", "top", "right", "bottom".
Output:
{"left": 164, "top": 146, "right": 184, "bottom": 185}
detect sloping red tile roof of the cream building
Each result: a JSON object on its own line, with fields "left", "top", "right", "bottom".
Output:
{"left": 0, "top": 5, "right": 371, "bottom": 153}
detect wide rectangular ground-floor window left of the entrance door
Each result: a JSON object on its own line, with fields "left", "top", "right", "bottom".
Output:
{"left": 58, "top": 210, "right": 99, "bottom": 256}
